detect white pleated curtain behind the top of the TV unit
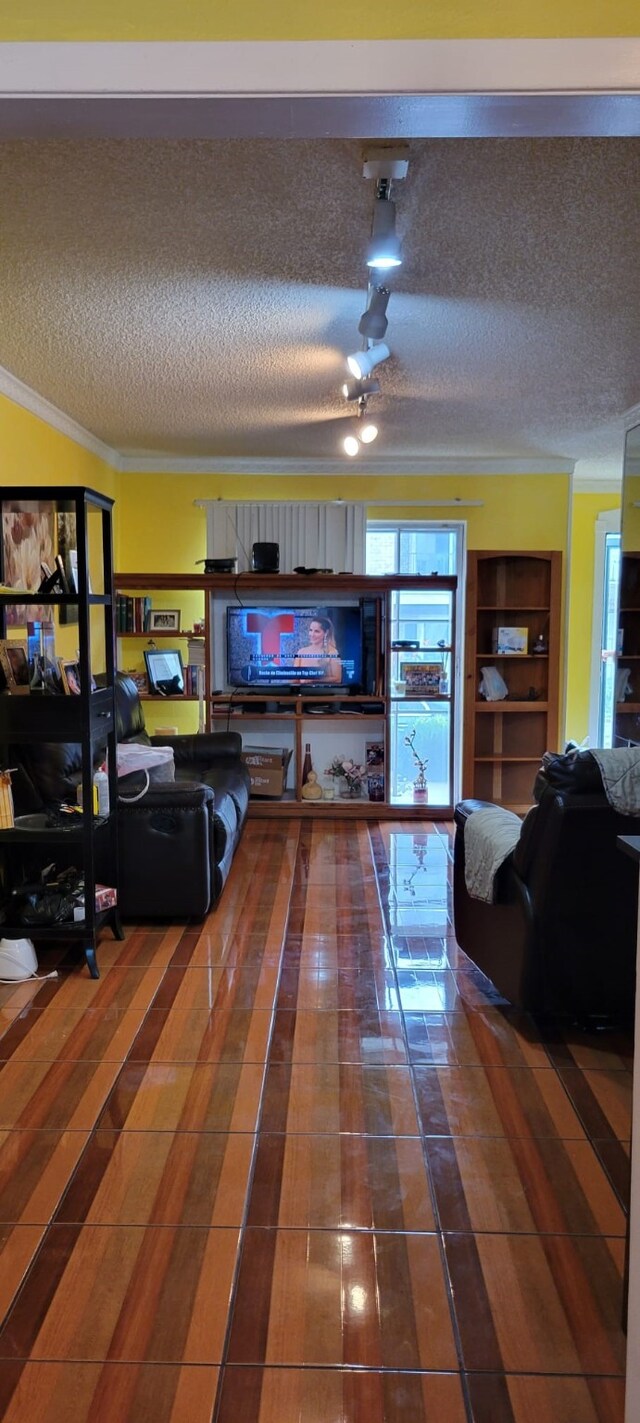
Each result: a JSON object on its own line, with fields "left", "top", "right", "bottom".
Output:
{"left": 198, "top": 499, "right": 367, "bottom": 573}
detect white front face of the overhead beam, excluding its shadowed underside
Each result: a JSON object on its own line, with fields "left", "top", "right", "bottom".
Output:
{"left": 0, "top": 36, "right": 640, "bottom": 98}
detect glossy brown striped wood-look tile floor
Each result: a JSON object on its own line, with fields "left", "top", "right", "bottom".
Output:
{"left": 0, "top": 821, "right": 631, "bottom": 1423}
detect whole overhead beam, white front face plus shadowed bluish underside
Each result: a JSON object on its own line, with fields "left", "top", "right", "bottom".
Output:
{"left": 0, "top": 36, "right": 640, "bottom": 141}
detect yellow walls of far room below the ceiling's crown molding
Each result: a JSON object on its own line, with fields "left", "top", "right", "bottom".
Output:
{"left": 0, "top": 396, "right": 616, "bottom": 740}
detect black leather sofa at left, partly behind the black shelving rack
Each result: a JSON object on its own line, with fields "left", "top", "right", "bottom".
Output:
{"left": 11, "top": 673, "right": 250, "bottom": 919}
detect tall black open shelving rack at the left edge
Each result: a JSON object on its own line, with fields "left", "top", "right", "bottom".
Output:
{"left": 0, "top": 485, "right": 124, "bottom": 978}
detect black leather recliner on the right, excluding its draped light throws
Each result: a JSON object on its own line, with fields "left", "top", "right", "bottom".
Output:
{"left": 454, "top": 751, "right": 640, "bottom": 1023}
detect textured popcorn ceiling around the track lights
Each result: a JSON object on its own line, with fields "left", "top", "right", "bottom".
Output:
{"left": 0, "top": 139, "right": 640, "bottom": 461}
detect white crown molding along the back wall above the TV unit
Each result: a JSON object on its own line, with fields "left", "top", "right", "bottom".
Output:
{"left": 118, "top": 454, "right": 573, "bottom": 480}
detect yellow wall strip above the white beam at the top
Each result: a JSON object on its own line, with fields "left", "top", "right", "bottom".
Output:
{"left": 0, "top": 0, "right": 639, "bottom": 41}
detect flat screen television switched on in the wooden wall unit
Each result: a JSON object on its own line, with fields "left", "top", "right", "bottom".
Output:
{"left": 226, "top": 603, "right": 363, "bottom": 692}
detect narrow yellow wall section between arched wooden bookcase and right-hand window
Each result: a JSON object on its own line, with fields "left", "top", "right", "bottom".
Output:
{"left": 566, "top": 494, "right": 620, "bottom": 741}
